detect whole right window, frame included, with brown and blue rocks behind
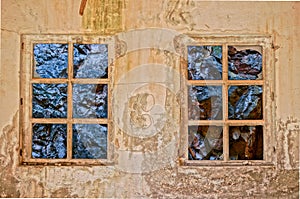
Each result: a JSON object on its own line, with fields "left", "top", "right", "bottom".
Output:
{"left": 181, "top": 36, "right": 273, "bottom": 165}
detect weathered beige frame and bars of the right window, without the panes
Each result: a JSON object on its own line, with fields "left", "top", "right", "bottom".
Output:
{"left": 179, "top": 35, "right": 275, "bottom": 166}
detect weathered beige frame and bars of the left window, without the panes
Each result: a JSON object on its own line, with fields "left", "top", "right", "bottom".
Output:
{"left": 19, "top": 34, "right": 115, "bottom": 165}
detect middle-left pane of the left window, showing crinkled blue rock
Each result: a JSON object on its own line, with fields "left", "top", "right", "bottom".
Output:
{"left": 32, "top": 84, "right": 67, "bottom": 118}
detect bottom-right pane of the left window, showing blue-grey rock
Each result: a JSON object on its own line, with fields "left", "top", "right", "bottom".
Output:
{"left": 72, "top": 124, "right": 107, "bottom": 159}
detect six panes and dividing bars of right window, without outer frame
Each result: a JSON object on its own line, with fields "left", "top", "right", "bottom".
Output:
{"left": 185, "top": 44, "right": 264, "bottom": 161}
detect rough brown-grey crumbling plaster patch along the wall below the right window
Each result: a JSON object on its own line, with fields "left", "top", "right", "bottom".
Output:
{"left": 145, "top": 167, "right": 299, "bottom": 198}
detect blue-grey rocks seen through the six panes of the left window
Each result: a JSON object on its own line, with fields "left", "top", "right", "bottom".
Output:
{"left": 31, "top": 43, "right": 108, "bottom": 159}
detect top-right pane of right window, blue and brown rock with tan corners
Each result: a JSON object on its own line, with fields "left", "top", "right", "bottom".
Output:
{"left": 228, "top": 46, "right": 262, "bottom": 80}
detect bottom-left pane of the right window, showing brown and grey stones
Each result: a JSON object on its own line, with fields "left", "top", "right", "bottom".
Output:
{"left": 188, "top": 126, "right": 223, "bottom": 160}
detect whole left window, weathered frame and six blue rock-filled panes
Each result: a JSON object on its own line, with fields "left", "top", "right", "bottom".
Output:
{"left": 20, "top": 35, "right": 114, "bottom": 164}
